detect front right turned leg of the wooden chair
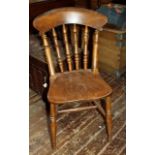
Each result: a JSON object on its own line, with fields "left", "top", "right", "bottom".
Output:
{"left": 105, "top": 96, "right": 112, "bottom": 141}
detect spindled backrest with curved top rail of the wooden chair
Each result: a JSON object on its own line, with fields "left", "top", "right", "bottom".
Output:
{"left": 33, "top": 7, "right": 107, "bottom": 76}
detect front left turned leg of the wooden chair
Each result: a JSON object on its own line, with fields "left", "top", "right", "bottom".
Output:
{"left": 50, "top": 103, "right": 57, "bottom": 149}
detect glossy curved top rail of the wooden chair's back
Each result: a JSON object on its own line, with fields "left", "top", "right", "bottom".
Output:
{"left": 33, "top": 7, "right": 107, "bottom": 33}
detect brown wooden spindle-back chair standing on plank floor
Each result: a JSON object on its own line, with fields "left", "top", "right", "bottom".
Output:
{"left": 33, "top": 7, "right": 112, "bottom": 148}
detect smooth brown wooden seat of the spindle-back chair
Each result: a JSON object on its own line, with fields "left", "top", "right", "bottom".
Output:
{"left": 48, "top": 70, "right": 112, "bottom": 103}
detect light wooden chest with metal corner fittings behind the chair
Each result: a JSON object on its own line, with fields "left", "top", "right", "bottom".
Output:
{"left": 99, "top": 28, "right": 126, "bottom": 77}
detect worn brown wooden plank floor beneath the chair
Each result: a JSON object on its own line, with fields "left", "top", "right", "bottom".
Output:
{"left": 29, "top": 74, "right": 126, "bottom": 155}
